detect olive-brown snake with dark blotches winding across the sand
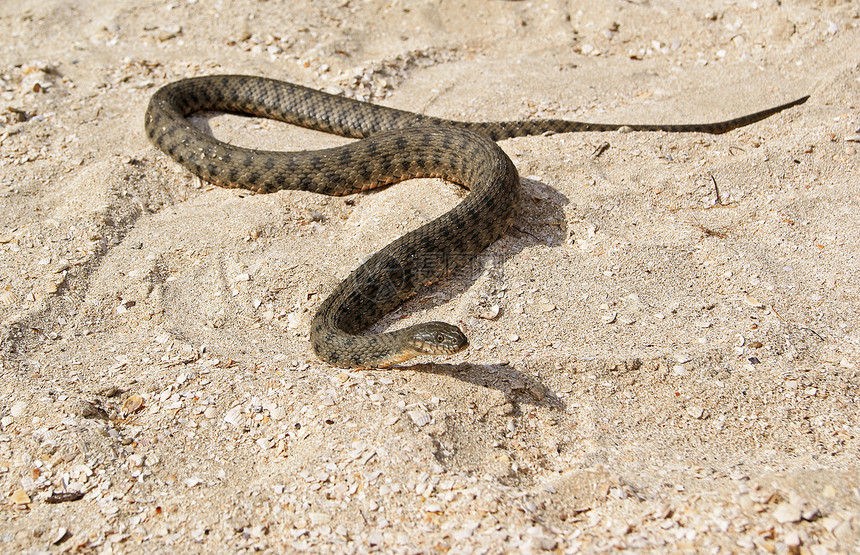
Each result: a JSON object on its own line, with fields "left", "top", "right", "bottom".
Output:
{"left": 144, "top": 75, "right": 809, "bottom": 368}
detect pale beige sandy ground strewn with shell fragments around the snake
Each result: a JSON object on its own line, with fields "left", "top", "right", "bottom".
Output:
{"left": 0, "top": 0, "right": 860, "bottom": 554}
